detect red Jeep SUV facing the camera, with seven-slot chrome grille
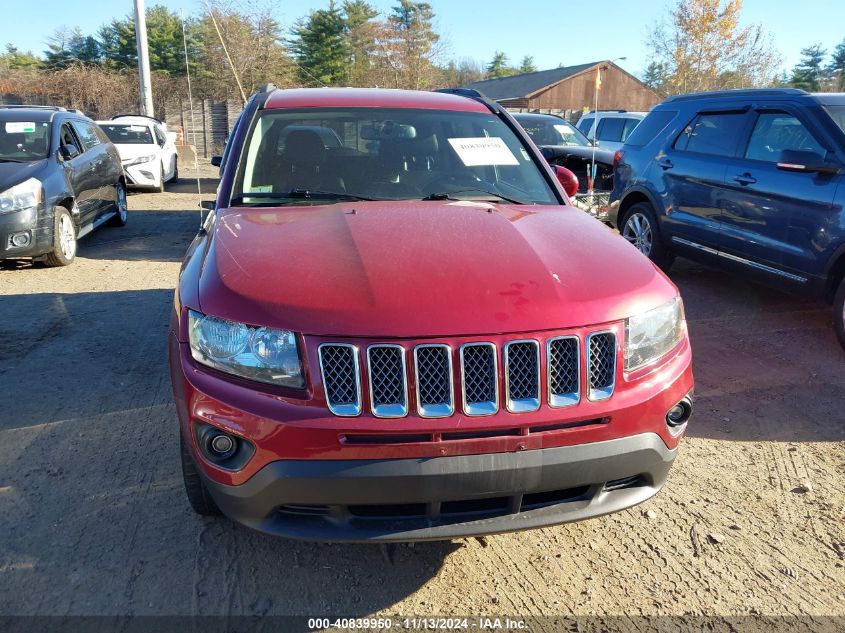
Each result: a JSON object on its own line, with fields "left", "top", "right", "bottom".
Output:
{"left": 169, "top": 88, "right": 693, "bottom": 541}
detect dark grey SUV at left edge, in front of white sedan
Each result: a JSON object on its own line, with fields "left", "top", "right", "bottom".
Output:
{"left": 0, "top": 106, "right": 127, "bottom": 266}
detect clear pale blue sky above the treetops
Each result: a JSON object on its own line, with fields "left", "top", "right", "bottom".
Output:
{"left": 0, "top": 0, "right": 845, "bottom": 75}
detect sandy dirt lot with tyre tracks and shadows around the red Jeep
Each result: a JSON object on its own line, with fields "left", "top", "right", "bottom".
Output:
{"left": 0, "top": 159, "right": 845, "bottom": 628}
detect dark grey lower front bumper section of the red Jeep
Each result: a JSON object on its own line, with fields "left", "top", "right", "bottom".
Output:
{"left": 200, "top": 433, "right": 677, "bottom": 541}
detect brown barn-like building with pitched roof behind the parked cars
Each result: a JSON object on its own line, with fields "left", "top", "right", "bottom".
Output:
{"left": 464, "top": 61, "right": 663, "bottom": 113}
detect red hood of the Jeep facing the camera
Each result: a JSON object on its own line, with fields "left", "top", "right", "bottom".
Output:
{"left": 199, "top": 201, "right": 676, "bottom": 338}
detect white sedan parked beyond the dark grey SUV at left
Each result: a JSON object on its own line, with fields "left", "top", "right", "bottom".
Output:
{"left": 97, "top": 115, "right": 179, "bottom": 191}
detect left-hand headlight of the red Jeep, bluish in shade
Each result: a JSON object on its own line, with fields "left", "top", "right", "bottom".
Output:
{"left": 188, "top": 310, "right": 305, "bottom": 389}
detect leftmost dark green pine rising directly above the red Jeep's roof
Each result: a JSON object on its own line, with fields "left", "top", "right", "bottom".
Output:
{"left": 289, "top": 0, "right": 350, "bottom": 86}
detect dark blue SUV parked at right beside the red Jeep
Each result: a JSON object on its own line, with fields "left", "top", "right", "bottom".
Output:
{"left": 608, "top": 89, "right": 845, "bottom": 347}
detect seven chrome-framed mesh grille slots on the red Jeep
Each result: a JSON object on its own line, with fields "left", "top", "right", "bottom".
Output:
{"left": 319, "top": 332, "right": 617, "bottom": 418}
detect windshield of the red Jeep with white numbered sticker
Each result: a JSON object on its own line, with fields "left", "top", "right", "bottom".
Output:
{"left": 232, "top": 107, "right": 559, "bottom": 206}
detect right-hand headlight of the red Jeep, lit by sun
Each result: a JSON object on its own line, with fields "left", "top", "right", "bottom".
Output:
{"left": 625, "top": 297, "right": 686, "bottom": 371}
